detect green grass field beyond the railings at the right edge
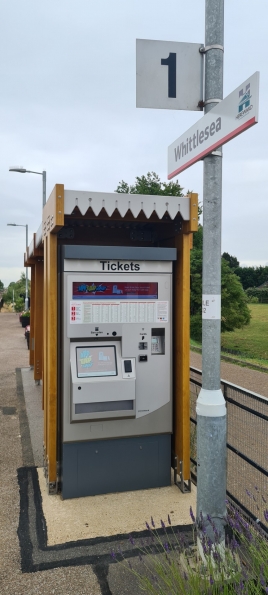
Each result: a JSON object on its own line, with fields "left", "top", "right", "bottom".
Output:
{"left": 191, "top": 304, "right": 268, "bottom": 368}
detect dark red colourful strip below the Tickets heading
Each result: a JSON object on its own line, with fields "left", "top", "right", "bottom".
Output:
{"left": 72, "top": 281, "right": 158, "bottom": 300}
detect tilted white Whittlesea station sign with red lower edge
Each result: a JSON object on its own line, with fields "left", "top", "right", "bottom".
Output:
{"left": 168, "top": 72, "right": 260, "bottom": 180}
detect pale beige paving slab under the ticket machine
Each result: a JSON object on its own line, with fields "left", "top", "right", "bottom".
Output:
{"left": 37, "top": 469, "right": 196, "bottom": 545}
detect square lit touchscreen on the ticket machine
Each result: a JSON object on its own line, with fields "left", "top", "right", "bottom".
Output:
{"left": 76, "top": 345, "right": 117, "bottom": 378}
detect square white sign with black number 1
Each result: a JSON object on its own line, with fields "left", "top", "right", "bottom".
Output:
{"left": 136, "top": 39, "right": 203, "bottom": 111}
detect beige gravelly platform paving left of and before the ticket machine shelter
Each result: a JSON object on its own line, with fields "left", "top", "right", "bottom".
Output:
{"left": 0, "top": 313, "right": 195, "bottom": 595}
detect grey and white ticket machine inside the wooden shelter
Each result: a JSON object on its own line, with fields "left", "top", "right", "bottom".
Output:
{"left": 59, "top": 245, "right": 176, "bottom": 498}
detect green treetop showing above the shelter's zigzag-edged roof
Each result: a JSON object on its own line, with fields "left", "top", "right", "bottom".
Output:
{"left": 115, "top": 171, "right": 183, "bottom": 196}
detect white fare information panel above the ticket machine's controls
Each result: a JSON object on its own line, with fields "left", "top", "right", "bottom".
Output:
{"left": 70, "top": 299, "right": 168, "bottom": 324}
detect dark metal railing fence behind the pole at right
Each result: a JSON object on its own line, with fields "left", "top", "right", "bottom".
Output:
{"left": 190, "top": 367, "right": 268, "bottom": 531}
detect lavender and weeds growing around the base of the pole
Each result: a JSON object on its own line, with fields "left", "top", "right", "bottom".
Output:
{"left": 112, "top": 502, "right": 268, "bottom": 595}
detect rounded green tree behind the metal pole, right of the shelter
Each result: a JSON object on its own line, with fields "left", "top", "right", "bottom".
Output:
{"left": 190, "top": 226, "right": 250, "bottom": 341}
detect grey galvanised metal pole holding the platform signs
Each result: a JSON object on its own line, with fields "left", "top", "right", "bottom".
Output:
{"left": 196, "top": 0, "right": 226, "bottom": 546}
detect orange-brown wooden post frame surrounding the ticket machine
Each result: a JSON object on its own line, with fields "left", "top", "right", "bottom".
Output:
{"left": 27, "top": 184, "right": 198, "bottom": 493}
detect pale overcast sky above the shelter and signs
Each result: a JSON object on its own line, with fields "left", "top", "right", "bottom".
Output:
{"left": 0, "top": 0, "right": 268, "bottom": 286}
